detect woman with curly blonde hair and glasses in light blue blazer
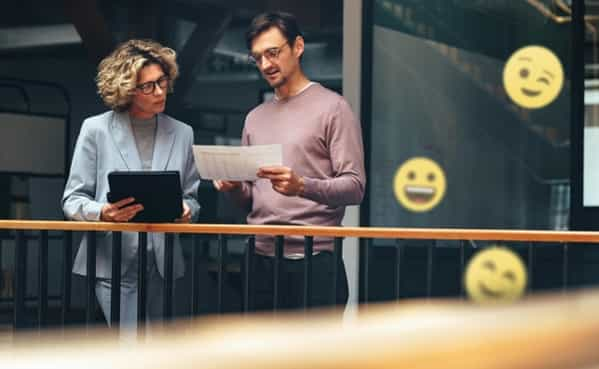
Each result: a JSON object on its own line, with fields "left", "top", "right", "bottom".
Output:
{"left": 62, "top": 40, "right": 200, "bottom": 328}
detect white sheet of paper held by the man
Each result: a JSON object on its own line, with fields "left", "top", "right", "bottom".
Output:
{"left": 193, "top": 144, "right": 283, "bottom": 181}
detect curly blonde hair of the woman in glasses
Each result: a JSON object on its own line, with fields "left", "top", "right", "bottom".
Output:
{"left": 96, "top": 40, "right": 179, "bottom": 112}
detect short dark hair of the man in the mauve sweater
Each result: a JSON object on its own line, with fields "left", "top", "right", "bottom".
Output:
{"left": 245, "top": 12, "right": 303, "bottom": 50}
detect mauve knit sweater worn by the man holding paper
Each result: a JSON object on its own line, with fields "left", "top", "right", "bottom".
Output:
{"left": 230, "top": 83, "right": 366, "bottom": 255}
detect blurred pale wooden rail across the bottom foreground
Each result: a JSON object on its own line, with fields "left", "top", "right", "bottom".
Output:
{"left": 5, "top": 290, "right": 599, "bottom": 369}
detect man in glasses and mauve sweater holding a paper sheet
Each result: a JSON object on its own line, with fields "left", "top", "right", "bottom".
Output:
{"left": 214, "top": 13, "right": 366, "bottom": 310}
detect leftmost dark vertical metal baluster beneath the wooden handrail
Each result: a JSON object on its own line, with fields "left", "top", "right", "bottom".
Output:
{"left": 13, "top": 231, "right": 27, "bottom": 330}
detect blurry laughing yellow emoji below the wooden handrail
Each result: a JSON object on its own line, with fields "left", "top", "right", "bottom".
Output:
{"left": 464, "top": 246, "right": 527, "bottom": 304}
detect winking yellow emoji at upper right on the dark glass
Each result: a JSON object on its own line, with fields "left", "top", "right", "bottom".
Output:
{"left": 503, "top": 46, "right": 564, "bottom": 109}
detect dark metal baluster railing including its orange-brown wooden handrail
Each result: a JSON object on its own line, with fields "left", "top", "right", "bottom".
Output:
{"left": 0, "top": 220, "right": 599, "bottom": 330}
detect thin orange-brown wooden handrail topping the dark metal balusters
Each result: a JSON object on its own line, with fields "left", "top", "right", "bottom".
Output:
{"left": 0, "top": 220, "right": 599, "bottom": 243}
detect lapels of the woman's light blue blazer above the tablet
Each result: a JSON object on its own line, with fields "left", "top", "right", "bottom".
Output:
{"left": 110, "top": 112, "right": 175, "bottom": 170}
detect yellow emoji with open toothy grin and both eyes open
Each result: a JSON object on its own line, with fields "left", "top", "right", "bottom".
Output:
{"left": 393, "top": 157, "right": 446, "bottom": 212}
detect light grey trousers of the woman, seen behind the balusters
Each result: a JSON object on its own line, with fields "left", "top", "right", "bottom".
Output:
{"left": 96, "top": 251, "right": 164, "bottom": 330}
